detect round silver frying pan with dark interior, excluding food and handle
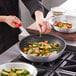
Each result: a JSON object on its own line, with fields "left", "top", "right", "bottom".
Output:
{"left": 19, "top": 34, "right": 66, "bottom": 62}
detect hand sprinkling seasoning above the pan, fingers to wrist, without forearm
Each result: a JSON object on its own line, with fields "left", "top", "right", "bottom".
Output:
{"left": 36, "top": 19, "right": 51, "bottom": 34}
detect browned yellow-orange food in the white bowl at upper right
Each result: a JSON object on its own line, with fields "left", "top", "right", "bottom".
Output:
{"left": 53, "top": 21, "right": 72, "bottom": 28}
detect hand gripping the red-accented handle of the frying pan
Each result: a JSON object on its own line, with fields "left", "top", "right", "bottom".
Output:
{"left": 4, "top": 16, "right": 21, "bottom": 28}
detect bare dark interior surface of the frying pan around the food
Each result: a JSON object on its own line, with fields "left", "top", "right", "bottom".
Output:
{"left": 19, "top": 34, "right": 65, "bottom": 51}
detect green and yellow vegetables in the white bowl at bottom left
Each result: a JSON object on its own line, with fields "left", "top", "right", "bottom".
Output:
{"left": 0, "top": 68, "right": 31, "bottom": 76}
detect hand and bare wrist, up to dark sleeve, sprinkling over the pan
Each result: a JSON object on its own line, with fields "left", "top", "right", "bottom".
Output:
{"left": 35, "top": 10, "right": 51, "bottom": 34}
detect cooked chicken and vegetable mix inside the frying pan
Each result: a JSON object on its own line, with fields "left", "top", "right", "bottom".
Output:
{"left": 23, "top": 41, "right": 60, "bottom": 57}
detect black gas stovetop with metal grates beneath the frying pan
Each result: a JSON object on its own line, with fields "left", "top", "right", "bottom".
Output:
{"left": 12, "top": 46, "right": 76, "bottom": 76}
